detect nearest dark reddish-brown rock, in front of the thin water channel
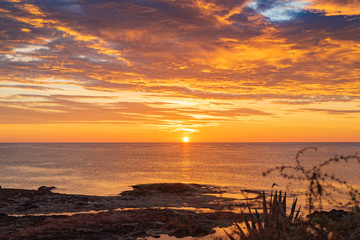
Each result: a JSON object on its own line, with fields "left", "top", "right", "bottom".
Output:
{"left": 0, "top": 209, "right": 246, "bottom": 239}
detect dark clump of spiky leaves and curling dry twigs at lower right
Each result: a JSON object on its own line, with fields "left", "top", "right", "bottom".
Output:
{"left": 225, "top": 148, "right": 360, "bottom": 240}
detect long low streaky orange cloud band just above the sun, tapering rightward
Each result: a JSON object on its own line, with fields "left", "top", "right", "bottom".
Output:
{"left": 0, "top": 94, "right": 271, "bottom": 126}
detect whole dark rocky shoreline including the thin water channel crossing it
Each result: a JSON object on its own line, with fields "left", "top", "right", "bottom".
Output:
{"left": 0, "top": 183, "right": 261, "bottom": 239}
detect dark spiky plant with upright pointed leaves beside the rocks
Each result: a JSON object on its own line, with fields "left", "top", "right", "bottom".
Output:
{"left": 224, "top": 191, "right": 306, "bottom": 240}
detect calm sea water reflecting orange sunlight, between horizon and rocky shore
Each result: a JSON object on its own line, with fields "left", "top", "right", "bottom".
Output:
{"left": 0, "top": 143, "right": 360, "bottom": 199}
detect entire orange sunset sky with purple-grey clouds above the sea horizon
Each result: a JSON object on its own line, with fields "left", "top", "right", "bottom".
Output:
{"left": 0, "top": 0, "right": 360, "bottom": 142}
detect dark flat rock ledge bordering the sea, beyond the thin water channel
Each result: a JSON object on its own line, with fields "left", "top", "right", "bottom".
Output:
{"left": 0, "top": 183, "right": 255, "bottom": 215}
